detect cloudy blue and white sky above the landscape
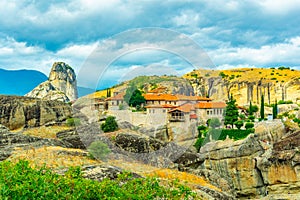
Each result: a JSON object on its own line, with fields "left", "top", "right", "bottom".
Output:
{"left": 0, "top": 0, "right": 300, "bottom": 88}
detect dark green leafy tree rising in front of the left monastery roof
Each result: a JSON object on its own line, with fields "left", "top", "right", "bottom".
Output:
{"left": 124, "top": 85, "right": 146, "bottom": 107}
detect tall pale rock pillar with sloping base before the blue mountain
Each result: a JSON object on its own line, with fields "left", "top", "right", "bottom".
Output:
{"left": 25, "top": 62, "right": 78, "bottom": 102}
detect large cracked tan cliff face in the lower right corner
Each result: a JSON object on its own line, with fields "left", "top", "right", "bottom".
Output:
{"left": 200, "top": 121, "right": 300, "bottom": 199}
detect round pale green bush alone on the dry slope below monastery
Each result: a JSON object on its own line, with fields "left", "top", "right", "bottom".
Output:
{"left": 87, "top": 140, "right": 111, "bottom": 160}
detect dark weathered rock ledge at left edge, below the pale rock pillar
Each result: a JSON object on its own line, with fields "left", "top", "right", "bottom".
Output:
{"left": 0, "top": 95, "right": 71, "bottom": 130}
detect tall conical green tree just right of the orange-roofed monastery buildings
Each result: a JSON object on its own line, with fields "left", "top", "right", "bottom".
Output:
{"left": 224, "top": 95, "right": 239, "bottom": 128}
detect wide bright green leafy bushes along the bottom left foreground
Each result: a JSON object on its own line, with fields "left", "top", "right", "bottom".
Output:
{"left": 0, "top": 160, "right": 195, "bottom": 200}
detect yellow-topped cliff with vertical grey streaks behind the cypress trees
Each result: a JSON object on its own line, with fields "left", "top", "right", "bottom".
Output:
{"left": 184, "top": 68, "right": 300, "bottom": 105}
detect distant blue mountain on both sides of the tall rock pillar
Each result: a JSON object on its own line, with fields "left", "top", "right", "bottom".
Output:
{"left": 0, "top": 69, "right": 95, "bottom": 97}
